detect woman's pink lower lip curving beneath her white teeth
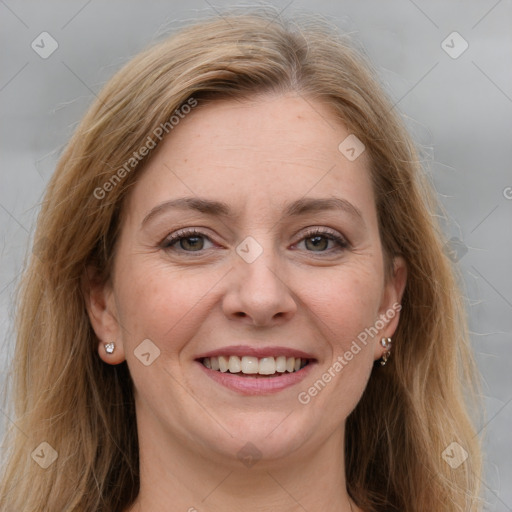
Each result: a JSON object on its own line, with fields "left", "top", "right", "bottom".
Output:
{"left": 197, "top": 361, "right": 315, "bottom": 395}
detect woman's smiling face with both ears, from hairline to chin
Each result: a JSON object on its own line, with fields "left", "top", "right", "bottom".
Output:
{"left": 91, "top": 94, "right": 405, "bottom": 468}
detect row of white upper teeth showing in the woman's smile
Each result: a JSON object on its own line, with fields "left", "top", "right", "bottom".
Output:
{"left": 202, "top": 356, "right": 308, "bottom": 375}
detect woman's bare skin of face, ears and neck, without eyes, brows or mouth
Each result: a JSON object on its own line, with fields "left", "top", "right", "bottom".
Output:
{"left": 88, "top": 93, "right": 406, "bottom": 512}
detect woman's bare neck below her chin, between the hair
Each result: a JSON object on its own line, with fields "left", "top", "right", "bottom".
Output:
{"left": 126, "top": 414, "right": 359, "bottom": 512}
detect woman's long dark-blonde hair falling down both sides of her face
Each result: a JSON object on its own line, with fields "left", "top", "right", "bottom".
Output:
{"left": 0, "top": 13, "right": 480, "bottom": 512}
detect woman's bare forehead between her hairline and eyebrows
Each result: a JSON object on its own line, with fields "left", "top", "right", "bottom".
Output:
{"left": 127, "top": 94, "right": 373, "bottom": 220}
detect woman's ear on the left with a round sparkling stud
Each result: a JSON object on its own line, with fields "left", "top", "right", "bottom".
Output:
{"left": 82, "top": 268, "right": 125, "bottom": 364}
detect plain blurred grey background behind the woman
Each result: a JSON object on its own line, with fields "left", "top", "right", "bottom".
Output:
{"left": 0, "top": 0, "right": 512, "bottom": 512}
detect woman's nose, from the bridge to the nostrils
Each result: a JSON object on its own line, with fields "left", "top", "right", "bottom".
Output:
{"left": 222, "top": 251, "right": 297, "bottom": 327}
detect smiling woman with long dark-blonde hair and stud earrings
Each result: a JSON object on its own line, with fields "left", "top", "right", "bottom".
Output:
{"left": 0, "top": 14, "right": 480, "bottom": 512}
